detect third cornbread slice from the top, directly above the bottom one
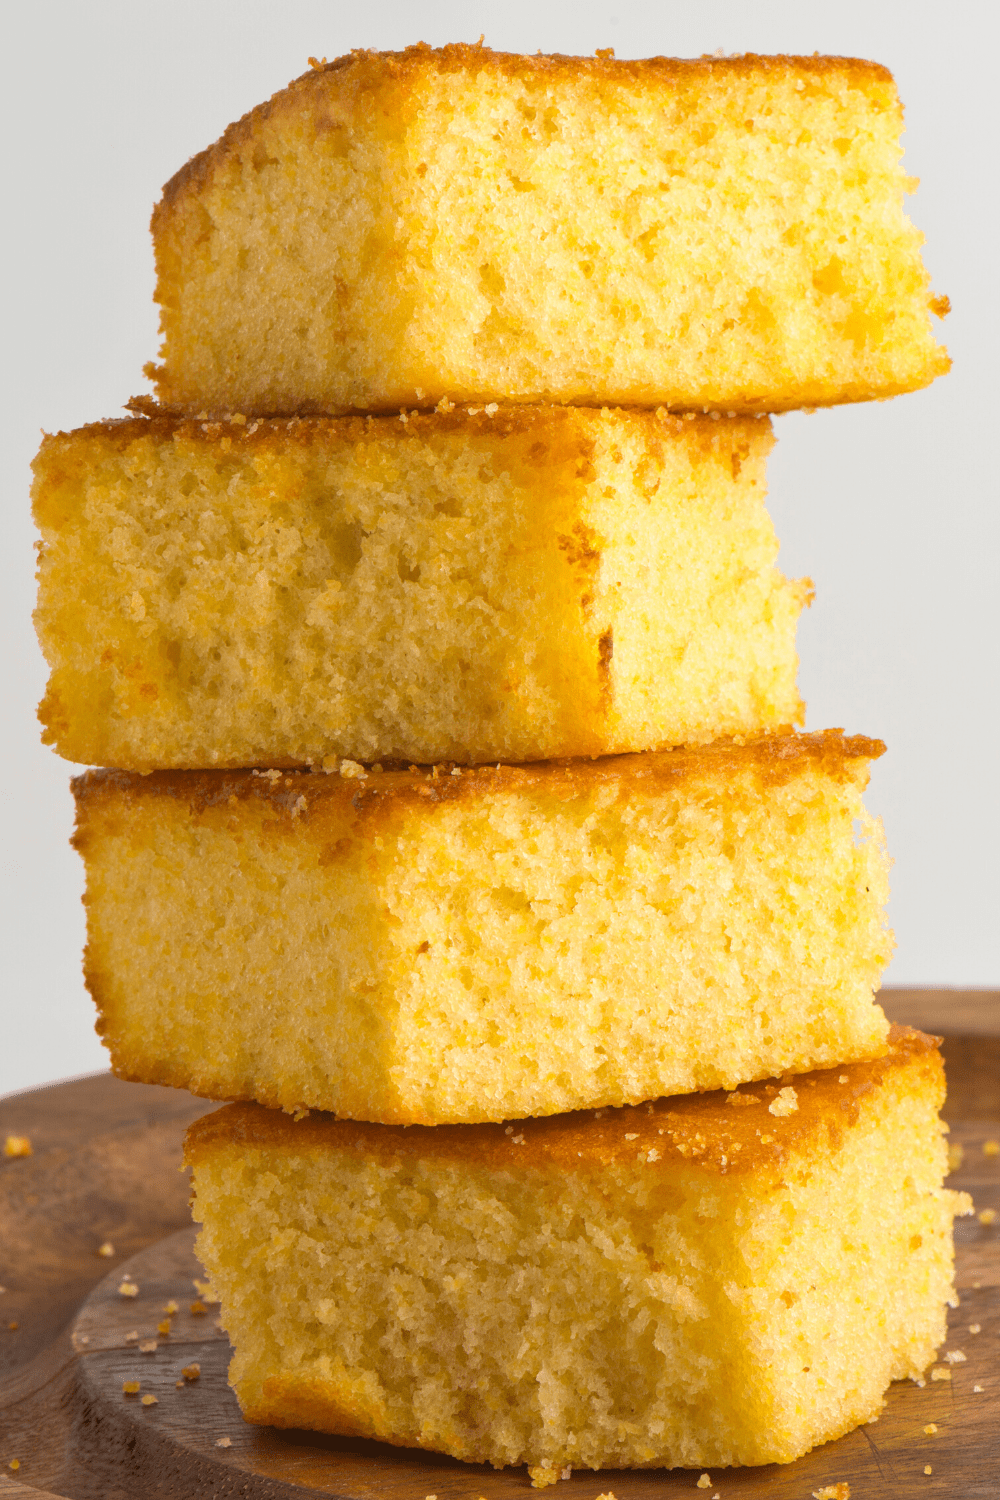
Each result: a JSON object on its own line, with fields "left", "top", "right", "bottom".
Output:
{"left": 73, "top": 731, "right": 892, "bottom": 1125}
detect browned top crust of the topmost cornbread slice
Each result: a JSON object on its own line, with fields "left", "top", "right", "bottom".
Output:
{"left": 153, "top": 42, "right": 892, "bottom": 216}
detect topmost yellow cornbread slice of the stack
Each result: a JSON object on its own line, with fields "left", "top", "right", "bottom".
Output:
{"left": 153, "top": 45, "right": 948, "bottom": 414}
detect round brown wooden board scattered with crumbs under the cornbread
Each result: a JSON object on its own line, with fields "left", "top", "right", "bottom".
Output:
{"left": 0, "top": 992, "right": 1000, "bottom": 1500}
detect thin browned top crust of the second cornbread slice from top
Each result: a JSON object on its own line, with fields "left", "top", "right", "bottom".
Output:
{"left": 31, "top": 396, "right": 771, "bottom": 461}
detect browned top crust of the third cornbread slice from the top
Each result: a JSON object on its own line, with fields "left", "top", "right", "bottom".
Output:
{"left": 72, "top": 729, "right": 886, "bottom": 825}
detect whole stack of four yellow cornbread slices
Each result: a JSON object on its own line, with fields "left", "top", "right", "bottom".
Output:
{"left": 34, "top": 47, "right": 963, "bottom": 1484}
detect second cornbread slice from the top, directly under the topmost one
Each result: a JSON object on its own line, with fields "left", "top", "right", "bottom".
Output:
{"left": 34, "top": 407, "right": 810, "bottom": 771}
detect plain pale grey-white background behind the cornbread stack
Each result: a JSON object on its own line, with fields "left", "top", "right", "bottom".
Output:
{"left": 0, "top": 0, "right": 1000, "bottom": 1092}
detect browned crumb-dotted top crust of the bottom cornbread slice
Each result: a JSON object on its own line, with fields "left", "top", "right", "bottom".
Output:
{"left": 186, "top": 1026, "right": 942, "bottom": 1175}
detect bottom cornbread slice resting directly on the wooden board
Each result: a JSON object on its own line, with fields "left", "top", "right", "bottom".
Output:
{"left": 187, "top": 1028, "right": 970, "bottom": 1470}
